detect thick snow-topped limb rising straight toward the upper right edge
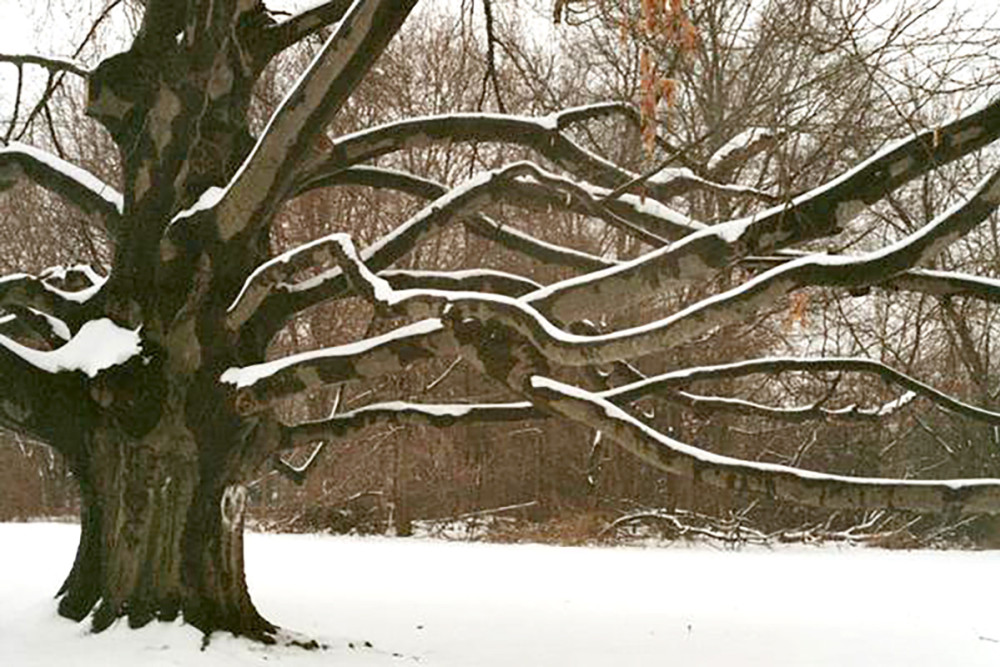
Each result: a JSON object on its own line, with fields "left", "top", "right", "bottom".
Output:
{"left": 533, "top": 100, "right": 1000, "bottom": 321}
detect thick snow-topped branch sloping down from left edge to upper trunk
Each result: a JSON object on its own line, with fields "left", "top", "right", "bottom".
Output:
{"left": 0, "top": 142, "right": 123, "bottom": 232}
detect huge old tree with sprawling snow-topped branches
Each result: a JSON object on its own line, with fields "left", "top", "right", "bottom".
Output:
{"left": 0, "top": 0, "right": 1000, "bottom": 639}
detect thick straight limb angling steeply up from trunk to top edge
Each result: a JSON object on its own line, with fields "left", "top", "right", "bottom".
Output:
{"left": 215, "top": 0, "right": 416, "bottom": 241}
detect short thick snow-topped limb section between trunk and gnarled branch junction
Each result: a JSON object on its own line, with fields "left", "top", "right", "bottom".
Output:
{"left": 219, "top": 319, "right": 457, "bottom": 415}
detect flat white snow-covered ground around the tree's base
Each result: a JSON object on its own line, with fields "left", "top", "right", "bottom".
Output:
{"left": 0, "top": 523, "right": 1000, "bottom": 667}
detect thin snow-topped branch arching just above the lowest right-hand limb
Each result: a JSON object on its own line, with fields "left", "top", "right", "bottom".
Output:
{"left": 602, "top": 357, "right": 1000, "bottom": 425}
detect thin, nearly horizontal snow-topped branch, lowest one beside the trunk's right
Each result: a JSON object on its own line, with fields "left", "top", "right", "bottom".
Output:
{"left": 281, "top": 401, "right": 548, "bottom": 449}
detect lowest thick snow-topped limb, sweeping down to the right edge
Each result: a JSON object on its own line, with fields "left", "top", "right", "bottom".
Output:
{"left": 531, "top": 375, "right": 1000, "bottom": 514}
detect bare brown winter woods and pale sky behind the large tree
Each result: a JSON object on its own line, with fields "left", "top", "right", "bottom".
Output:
{"left": 0, "top": 0, "right": 1000, "bottom": 546}
